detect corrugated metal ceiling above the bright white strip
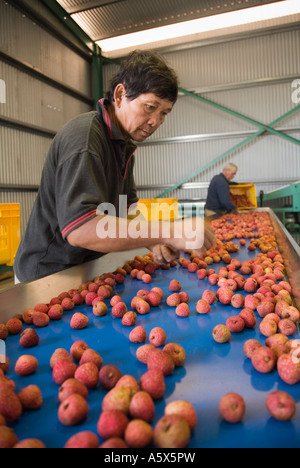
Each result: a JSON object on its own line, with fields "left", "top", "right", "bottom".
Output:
{"left": 57, "top": 0, "right": 288, "bottom": 41}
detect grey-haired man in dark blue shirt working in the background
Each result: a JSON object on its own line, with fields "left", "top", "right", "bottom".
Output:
{"left": 205, "top": 163, "right": 238, "bottom": 217}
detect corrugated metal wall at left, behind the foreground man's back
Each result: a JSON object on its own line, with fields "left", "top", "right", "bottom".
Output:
{"left": 0, "top": 0, "right": 92, "bottom": 232}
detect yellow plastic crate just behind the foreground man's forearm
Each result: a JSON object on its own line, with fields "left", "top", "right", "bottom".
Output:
{"left": 138, "top": 198, "right": 178, "bottom": 221}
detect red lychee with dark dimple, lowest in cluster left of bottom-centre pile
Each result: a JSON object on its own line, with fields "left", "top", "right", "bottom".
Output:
{"left": 58, "top": 393, "right": 89, "bottom": 426}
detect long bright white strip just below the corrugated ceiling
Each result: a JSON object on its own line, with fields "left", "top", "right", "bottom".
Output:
{"left": 97, "top": 0, "right": 300, "bottom": 53}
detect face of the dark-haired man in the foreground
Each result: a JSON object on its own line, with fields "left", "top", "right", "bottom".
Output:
{"left": 115, "top": 85, "right": 173, "bottom": 143}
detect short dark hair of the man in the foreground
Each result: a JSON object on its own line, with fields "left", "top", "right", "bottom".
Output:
{"left": 106, "top": 50, "right": 178, "bottom": 104}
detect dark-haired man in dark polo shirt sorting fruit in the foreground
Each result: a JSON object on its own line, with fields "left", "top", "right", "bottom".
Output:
{"left": 14, "top": 51, "right": 214, "bottom": 282}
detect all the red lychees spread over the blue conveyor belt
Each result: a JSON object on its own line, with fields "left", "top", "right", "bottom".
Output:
{"left": 0, "top": 212, "right": 300, "bottom": 448}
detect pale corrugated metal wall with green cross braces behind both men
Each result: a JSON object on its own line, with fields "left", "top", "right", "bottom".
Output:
{"left": 105, "top": 25, "right": 300, "bottom": 199}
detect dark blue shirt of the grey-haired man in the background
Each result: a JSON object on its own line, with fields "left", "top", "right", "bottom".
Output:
{"left": 205, "top": 173, "right": 236, "bottom": 214}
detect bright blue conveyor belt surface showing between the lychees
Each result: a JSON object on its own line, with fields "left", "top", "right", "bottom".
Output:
{"left": 2, "top": 239, "right": 300, "bottom": 448}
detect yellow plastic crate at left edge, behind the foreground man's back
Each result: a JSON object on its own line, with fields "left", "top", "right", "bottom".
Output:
{"left": 0, "top": 203, "right": 21, "bottom": 266}
